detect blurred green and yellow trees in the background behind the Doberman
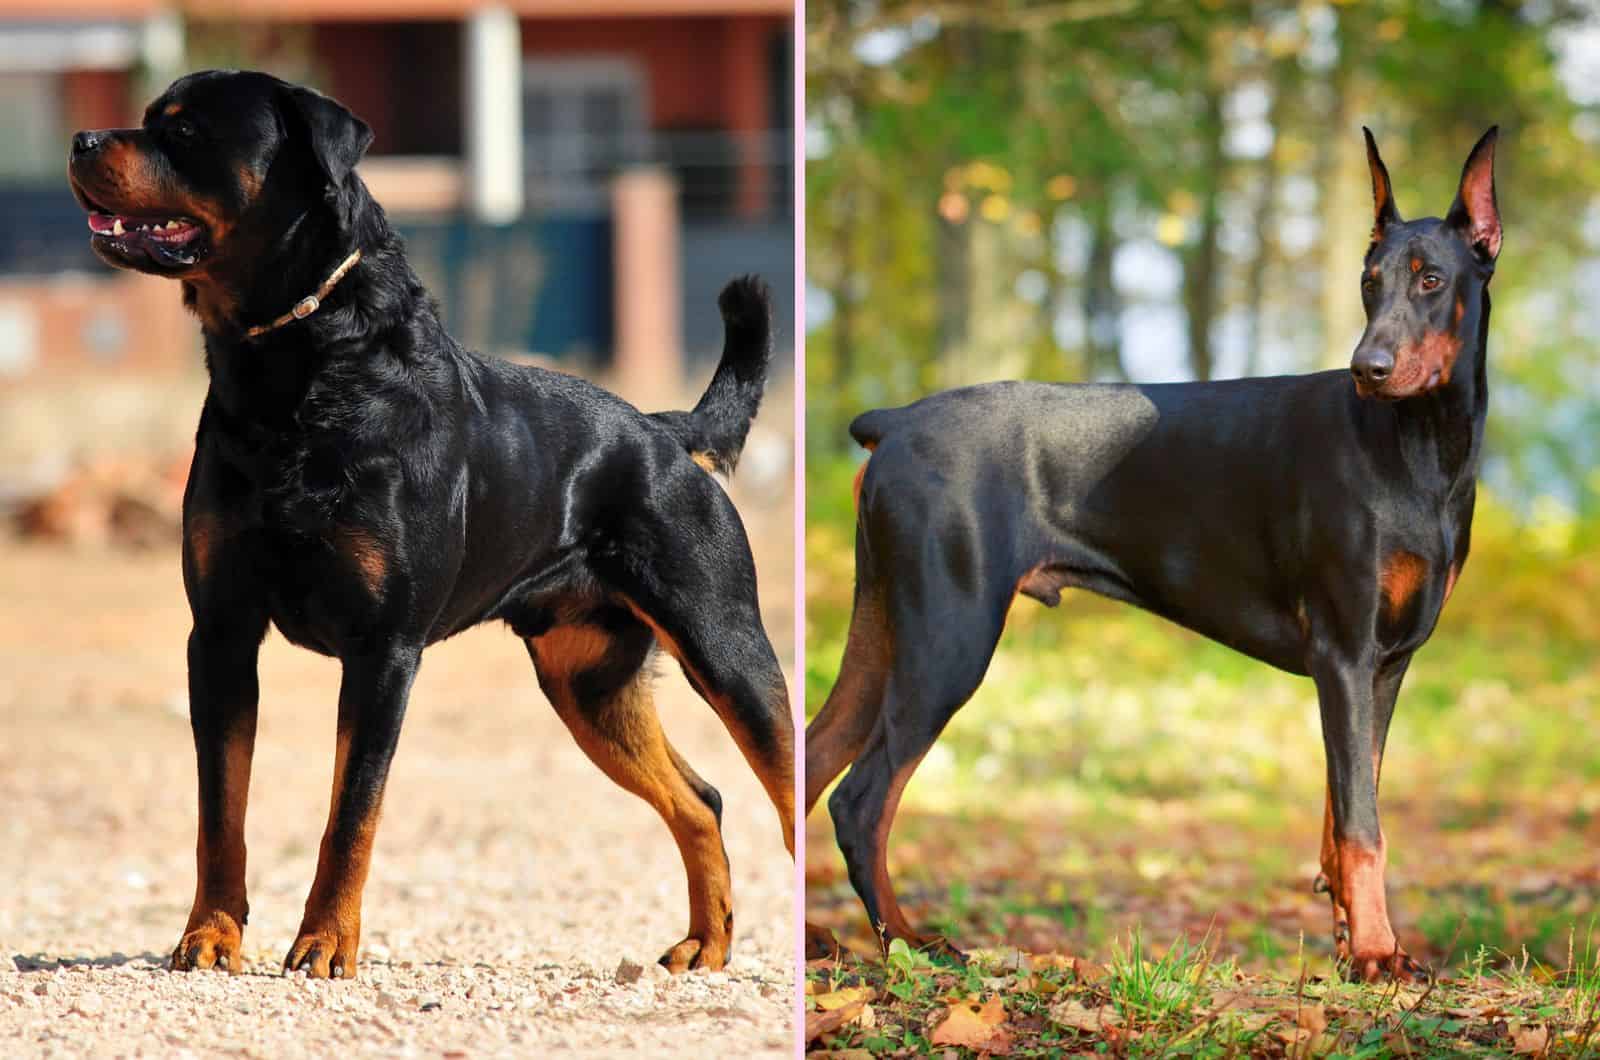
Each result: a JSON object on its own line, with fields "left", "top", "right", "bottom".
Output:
{"left": 806, "top": 0, "right": 1600, "bottom": 514}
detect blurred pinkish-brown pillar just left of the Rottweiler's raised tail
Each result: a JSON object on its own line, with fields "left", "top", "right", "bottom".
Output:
{"left": 611, "top": 168, "right": 683, "bottom": 407}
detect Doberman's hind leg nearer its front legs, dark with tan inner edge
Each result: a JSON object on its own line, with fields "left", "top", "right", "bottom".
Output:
{"left": 827, "top": 584, "right": 1008, "bottom": 956}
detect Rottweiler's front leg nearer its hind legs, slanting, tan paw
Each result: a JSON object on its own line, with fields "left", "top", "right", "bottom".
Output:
{"left": 283, "top": 644, "right": 422, "bottom": 978}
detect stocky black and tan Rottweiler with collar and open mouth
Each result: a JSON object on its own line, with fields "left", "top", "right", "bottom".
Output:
{"left": 69, "top": 72, "right": 794, "bottom": 977}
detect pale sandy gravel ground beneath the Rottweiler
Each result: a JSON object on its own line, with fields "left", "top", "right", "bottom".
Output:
{"left": 0, "top": 403, "right": 795, "bottom": 1057}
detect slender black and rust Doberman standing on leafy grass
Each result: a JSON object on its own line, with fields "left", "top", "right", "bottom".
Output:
{"left": 805, "top": 128, "right": 1501, "bottom": 980}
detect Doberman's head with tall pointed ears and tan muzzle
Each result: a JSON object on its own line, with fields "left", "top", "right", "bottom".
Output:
{"left": 1350, "top": 128, "right": 1501, "bottom": 400}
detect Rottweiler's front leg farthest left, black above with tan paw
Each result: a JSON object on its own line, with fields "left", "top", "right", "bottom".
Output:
{"left": 173, "top": 613, "right": 266, "bottom": 974}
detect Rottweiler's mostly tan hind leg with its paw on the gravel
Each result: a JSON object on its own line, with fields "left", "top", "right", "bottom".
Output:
{"left": 528, "top": 610, "right": 733, "bottom": 972}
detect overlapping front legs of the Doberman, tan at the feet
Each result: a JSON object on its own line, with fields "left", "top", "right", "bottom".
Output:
{"left": 1312, "top": 660, "right": 1426, "bottom": 982}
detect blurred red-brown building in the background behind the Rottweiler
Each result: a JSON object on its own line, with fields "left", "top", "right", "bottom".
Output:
{"left": 0, "top": 0, "right": 794, "bottom": 384}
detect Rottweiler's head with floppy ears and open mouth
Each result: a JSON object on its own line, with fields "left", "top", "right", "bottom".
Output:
{"left": 67, "top": 70, "right": 373, "bottom": 283}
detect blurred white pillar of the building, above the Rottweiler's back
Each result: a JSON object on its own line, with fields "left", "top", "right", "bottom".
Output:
{"left": 462, "top": 6, "right": 523, "bottom": 224}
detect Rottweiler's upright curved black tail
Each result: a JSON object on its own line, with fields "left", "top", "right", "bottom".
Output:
{"left": 650, "top": 275, "right": 773, "bottom": 474}
